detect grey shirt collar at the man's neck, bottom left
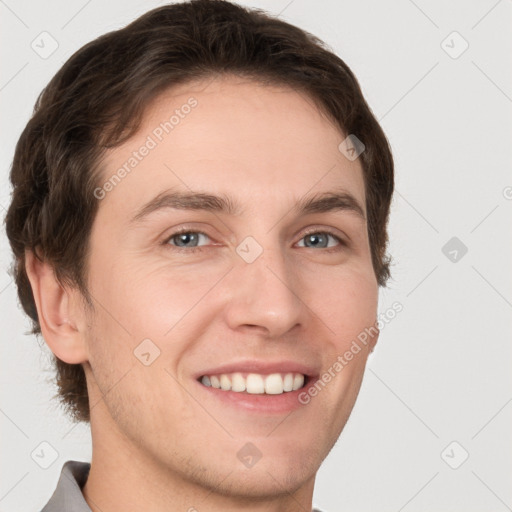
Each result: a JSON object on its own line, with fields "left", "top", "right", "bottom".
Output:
{"left": 41, "top": 460, "right": 92, "bottom": 512}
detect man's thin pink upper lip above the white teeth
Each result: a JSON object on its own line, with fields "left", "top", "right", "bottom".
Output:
{"left": 195, "top": 359, "right": 318, "bottom": 379}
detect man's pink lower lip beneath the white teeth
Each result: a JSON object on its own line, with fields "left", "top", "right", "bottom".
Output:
{"left": 196, "top": 378, "right": 316, "bottom": 414}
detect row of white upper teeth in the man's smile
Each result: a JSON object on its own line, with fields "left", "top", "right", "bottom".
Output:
{"left": 201, "top": 372, "right": 304, "bottom": 395}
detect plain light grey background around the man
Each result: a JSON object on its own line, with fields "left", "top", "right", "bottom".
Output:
{"left": 0, "top": 0, "right": 512, "bottom": 512}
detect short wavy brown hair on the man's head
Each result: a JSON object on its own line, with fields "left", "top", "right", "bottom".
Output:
{"left": 6, "top": 0, "right": 394, "bottom": 422}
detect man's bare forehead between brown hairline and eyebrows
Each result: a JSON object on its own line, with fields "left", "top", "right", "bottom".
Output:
{"left": 93, "top": 77, "right": 365, "bottom": 220}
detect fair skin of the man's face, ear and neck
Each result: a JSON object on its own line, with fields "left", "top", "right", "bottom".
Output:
{"left": 27, "top": 76, "right": 378, "bottom": 512}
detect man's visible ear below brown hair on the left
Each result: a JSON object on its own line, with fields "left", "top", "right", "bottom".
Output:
{"left": 25, "top": 249, "right": 88, "bottom": 364}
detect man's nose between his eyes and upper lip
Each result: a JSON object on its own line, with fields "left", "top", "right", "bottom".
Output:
{"left": 224, "top": 241, "right": 308, "bottom": 339}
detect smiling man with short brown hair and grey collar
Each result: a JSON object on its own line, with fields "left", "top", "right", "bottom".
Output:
{"left": 7, "top": 0, "right": 393, "bottom": 512}
